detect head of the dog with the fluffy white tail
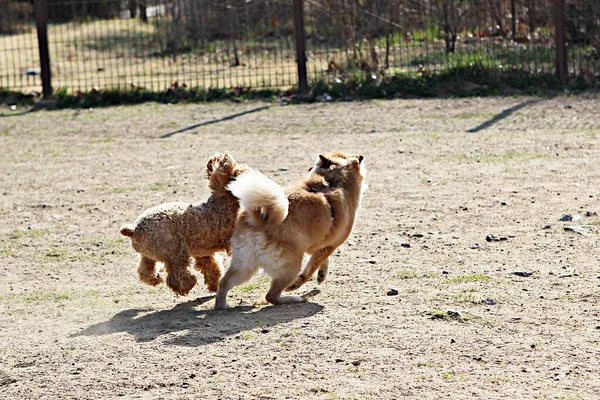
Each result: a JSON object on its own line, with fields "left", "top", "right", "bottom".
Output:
{"left": 310, "top": 153, "right": 366, "bottom": 188}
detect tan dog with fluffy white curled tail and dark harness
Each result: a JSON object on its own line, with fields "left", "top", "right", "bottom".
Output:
{"left": 215, "top": 153, "right": 366, "bottom": 309}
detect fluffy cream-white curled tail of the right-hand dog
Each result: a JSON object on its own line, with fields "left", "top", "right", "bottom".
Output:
{"left": 227, "top": 170, "right": 289, "bottom": 225}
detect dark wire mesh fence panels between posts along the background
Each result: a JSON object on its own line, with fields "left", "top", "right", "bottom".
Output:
{"left": 0, "top": 0, "right": 600, "bottom": 92}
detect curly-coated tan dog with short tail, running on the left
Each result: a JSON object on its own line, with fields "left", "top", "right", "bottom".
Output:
{"left": 121, "top": 153, "right": 250, "bottom": 296}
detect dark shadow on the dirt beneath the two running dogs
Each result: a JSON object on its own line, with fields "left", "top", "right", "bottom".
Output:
{"left": 71, "top": 292, "right": 323, "bottom": 347}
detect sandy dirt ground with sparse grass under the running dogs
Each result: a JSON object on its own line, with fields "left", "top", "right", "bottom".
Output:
{"left": 0, "top": 96, "right": 600, "bottom": 400}
